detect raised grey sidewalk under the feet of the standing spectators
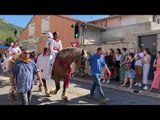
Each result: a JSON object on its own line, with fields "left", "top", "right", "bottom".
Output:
{"left": 71, "top": 76, "right": 160, "bottom": 98}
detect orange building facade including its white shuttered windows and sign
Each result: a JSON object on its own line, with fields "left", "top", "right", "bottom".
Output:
{"left": 19, "top": 15, "right": 82, "bottom": 53}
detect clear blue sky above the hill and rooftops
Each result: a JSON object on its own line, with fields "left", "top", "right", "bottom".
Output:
{"left": 0, "top": 15, "right": 107, "bottom": 28}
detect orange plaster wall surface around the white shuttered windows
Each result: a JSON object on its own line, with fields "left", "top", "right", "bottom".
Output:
{"left": 19, "top": 15, "right": 79, "bottom": 53}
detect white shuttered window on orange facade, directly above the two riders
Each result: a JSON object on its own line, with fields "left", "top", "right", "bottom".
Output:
{"left": 41, "top": 17, "right": 50, "bottom": 34}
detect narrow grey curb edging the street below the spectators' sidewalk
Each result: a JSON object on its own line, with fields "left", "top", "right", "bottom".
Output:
{"left": 71, "top": 77, "right": 160, "bottom": 98}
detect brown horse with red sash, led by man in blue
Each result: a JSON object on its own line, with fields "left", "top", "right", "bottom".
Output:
{"left": 50, "top": 47, "right": 87, "bottom": 101}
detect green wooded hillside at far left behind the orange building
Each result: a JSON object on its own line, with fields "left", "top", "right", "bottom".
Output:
{"left": 0, "top": 18, "right": 23, "bottom": 44}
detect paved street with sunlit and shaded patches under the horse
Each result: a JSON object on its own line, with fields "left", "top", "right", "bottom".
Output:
{"left": 0, "top": 77, "right": 160, "bottom": 105}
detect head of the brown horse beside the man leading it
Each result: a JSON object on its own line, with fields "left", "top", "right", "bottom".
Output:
{"left": 75, "top": 49, "right": 88, "bottom": 69}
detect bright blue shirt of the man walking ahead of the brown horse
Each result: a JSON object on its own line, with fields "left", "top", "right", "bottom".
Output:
{"left": 88, "top": 53, "right": 105, "bottom": 75}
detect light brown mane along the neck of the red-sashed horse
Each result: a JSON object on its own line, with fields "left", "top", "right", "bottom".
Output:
{"left": 57, "top": 47, "right": 82, "bottom": 59}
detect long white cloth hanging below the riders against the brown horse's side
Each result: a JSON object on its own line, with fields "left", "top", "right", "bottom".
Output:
{"left": 36, "top": 54, "right": 52, "bottom": 80}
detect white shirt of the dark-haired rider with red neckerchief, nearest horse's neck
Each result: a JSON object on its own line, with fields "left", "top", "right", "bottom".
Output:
{"left": 50, "top": 39, "right": 62, "bottom": 53}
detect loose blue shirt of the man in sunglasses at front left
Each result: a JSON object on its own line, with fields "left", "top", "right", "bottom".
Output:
{"left": 12, "top": 60, "right": 38, "bottom": 93}
